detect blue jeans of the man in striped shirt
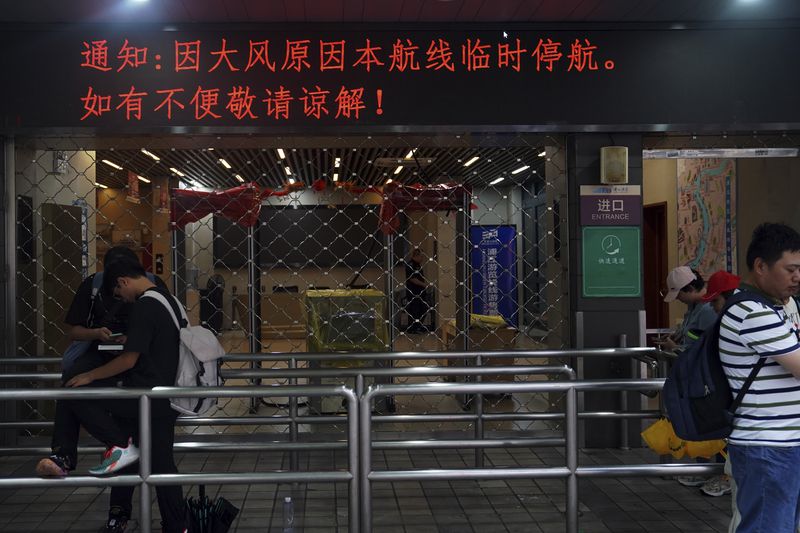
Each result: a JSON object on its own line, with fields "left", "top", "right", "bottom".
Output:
{"left": 728, "top": 444, "right": 800, "bottom": 533}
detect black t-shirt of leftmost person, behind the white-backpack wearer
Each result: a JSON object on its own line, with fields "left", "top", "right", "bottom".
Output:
{"left": 64, "top": 274, "right": 167, "bottom": 333}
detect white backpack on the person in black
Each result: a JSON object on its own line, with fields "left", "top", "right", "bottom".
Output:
{"left": 143, "top": 291, "right": 225, "bottom": 416}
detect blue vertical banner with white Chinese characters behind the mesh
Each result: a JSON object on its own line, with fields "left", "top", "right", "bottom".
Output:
{"left": 469, "top": 225, "right": 519, "bottom": 327}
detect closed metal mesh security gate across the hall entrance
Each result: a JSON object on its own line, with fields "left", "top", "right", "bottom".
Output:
{"left": 7, "top": 134, "right": 569, "bottom": 432}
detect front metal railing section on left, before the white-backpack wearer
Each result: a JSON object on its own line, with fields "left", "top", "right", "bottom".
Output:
{"left": 0, "top": 386, "right": 360, "bottom": 533}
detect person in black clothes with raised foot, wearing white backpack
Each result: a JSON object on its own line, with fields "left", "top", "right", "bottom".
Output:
{"left": 36, "top": 260, "right": 184, "bottom": 533}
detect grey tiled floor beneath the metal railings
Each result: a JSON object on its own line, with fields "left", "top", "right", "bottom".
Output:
{"left": 0, "top": 449, "right": 730, "bottom": 533}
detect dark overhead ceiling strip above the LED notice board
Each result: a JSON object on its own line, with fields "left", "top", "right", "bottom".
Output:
{"left": 0, "top": 0, "right": 800, "bottom": 24}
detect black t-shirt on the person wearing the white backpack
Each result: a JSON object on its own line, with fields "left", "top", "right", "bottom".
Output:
{"left": 123, "top": 288, "right": 180, "bottom": 388}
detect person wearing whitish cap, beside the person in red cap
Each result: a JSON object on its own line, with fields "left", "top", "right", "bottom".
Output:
{"left": 658, "top": 266, "right": 717, "bottom": 351}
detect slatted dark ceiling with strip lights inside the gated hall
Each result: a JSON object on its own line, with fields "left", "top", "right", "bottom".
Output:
{"left": 90, "top": 143, "right": 545, "bottom": 189}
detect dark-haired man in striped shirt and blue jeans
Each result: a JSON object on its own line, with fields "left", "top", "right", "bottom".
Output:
{"left": 719, "top": 224, "right": 800, "bottom": 533}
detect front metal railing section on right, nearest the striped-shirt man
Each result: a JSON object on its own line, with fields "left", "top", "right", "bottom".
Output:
{"left": 359, "top": 379, "right": 722, "bottom": 533}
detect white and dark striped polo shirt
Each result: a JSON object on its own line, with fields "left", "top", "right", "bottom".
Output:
{"left": 719, "top": 291, "right": 800, "bottom": 446}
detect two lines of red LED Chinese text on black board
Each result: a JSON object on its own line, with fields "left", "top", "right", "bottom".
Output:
{"left": 75, "top": 36, "right": 615, "bottom": 124}
